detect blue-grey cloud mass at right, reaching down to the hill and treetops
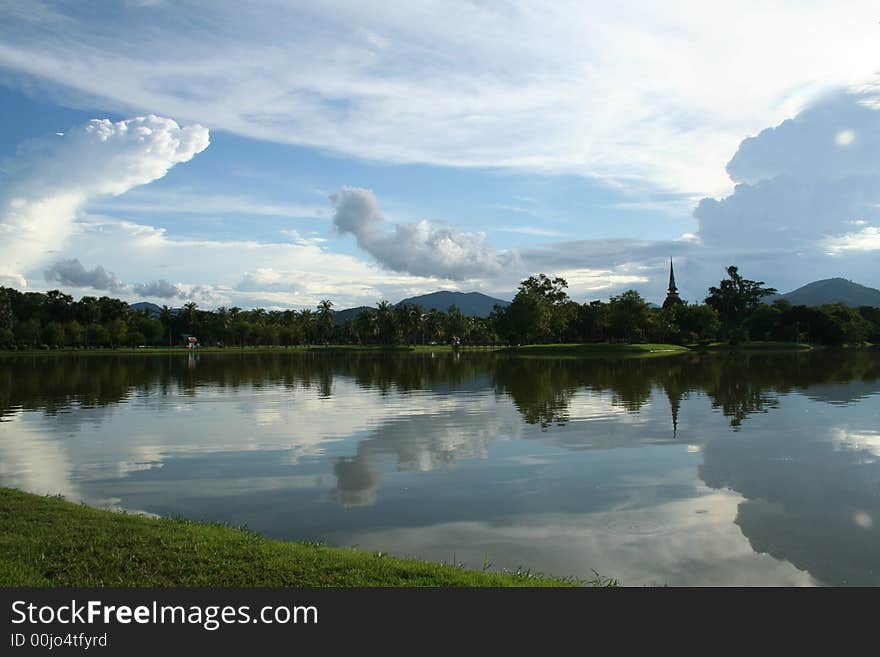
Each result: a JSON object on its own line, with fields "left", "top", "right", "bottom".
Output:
{"left": 694, "top": 91, "right": 880, "bottom": 289}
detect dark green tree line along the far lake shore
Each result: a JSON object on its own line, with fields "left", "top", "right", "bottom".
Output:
{"left": 0, "top": 266, "right": 880, "bottom": 349}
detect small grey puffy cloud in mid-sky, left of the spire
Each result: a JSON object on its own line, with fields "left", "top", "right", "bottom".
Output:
{"left": 330, "top": 187, "right": 517, "bottom": 280}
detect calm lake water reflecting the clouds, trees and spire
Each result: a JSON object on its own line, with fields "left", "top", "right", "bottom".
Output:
{"left": 0, "top": 351, "right": 880, "bottom": 585}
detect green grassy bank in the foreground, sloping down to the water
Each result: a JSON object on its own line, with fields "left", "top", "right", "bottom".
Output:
{"left": 0, "top": 488, "right": 611, "bottom": 587}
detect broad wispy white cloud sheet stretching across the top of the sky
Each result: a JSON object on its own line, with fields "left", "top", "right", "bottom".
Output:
{"left": 0, "top": 0, "right": 880, "bottom": 195}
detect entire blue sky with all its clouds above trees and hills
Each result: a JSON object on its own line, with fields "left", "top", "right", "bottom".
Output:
{"left": 0, "top": 0, "right": 880, "bottom": 309}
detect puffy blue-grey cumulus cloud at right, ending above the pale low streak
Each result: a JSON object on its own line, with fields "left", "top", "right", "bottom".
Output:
{"left": 694, "top": 92, "right": 880, "bottom": 250}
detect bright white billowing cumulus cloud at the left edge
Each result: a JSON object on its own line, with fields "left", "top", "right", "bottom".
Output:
{"left": 0, "top": 115, "right": 209, "bottom": 278}
